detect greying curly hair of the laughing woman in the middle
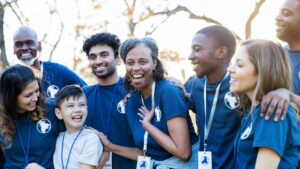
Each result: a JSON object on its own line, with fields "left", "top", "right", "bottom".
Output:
{"left": 120, "top": 37, "right": 167, "bottom": 90}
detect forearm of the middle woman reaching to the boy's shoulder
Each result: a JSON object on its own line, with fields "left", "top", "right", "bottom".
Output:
{"left": 100, "top": 133, "right": 144, "bottom": 160}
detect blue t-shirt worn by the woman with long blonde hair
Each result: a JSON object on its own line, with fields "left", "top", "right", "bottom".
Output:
{"left": 234, "top": 104, "right": 300, "bottom": 169}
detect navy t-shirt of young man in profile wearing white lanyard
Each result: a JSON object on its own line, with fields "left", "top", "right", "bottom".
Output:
{"left": 190, "top": 76, "right": 240, "bottom": 169}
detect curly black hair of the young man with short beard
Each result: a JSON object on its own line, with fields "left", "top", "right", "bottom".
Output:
{"left": 82, "top": 32, "right": 121, "bottom": 58}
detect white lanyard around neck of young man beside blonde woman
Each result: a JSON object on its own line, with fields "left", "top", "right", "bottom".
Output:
{"left": 203, "top": 72, "right": 229, "bottom": 151}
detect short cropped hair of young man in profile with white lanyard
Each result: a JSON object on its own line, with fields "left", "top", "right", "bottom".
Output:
{"left": 196, "top": 25, "right": 236, "bottom": 61}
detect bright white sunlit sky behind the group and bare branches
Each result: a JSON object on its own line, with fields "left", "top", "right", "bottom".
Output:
{"left": 1, "top": 0, "right": 282, "bottom": 83}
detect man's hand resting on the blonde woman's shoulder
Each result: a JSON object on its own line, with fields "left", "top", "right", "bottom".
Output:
{"left": 260, "top": 88, "right": 290, "bottom": 121}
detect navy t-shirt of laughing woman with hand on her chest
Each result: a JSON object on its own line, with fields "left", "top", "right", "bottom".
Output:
{"left": 125, "top": 80, "right": 198, "bottom": 161}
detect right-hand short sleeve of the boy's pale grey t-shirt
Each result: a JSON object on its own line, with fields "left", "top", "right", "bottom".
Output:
{"left": 79, "top": 133, "right": 103, "bottom": 166}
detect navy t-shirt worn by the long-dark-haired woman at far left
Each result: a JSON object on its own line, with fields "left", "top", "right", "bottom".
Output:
{"left": 1, "top": 99, "right": 63, "bottom": 169}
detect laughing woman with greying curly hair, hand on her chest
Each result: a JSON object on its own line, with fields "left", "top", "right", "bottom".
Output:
{"left": 116, "top": 38, "right": 198, "bottom": 169}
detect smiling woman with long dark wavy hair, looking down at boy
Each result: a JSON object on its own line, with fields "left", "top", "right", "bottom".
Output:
{"left": 0, "top": 65, "right": 59, "bottom": 169}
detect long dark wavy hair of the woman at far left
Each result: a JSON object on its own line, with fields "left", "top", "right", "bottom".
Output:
{"left": 0, "top": 65, "right": 45, "bottom": 147}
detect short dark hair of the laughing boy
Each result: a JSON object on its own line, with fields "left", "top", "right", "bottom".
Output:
{"left": 55, "top": 85, "right": 85, "bottom": 108}
